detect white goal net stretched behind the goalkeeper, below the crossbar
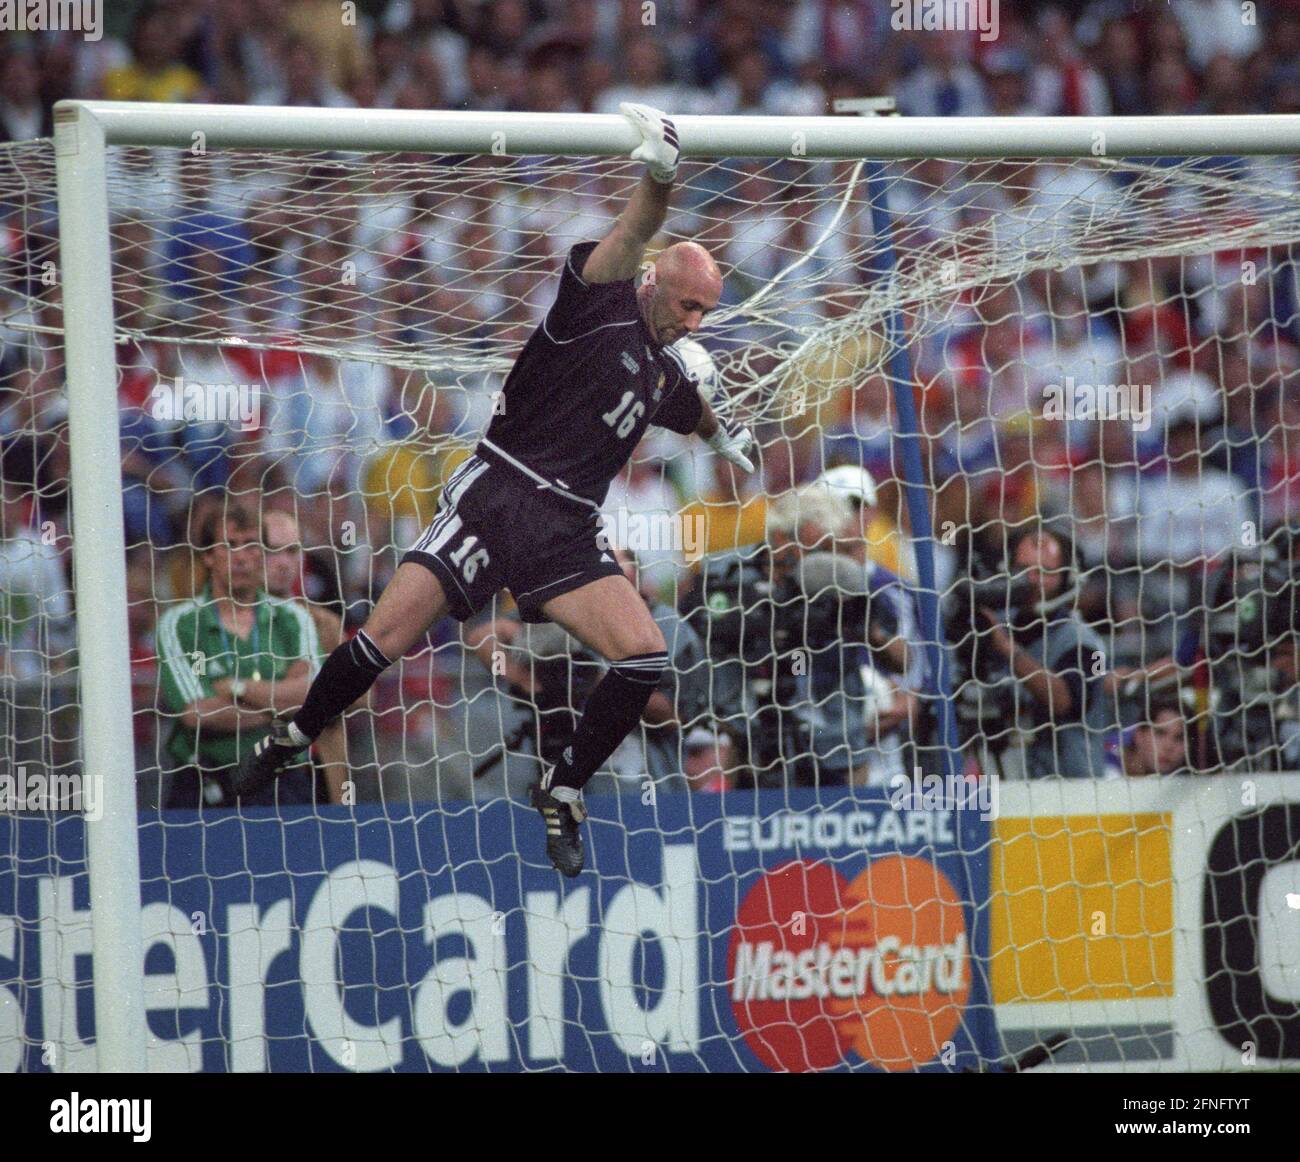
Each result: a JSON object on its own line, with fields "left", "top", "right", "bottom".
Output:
{"left": 0, "top": 113, "right": 1300, "bottom": 1071}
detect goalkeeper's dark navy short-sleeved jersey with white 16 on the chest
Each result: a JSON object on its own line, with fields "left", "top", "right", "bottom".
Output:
{"left": 478, "top": 242, "right": 703, "bottom": 507}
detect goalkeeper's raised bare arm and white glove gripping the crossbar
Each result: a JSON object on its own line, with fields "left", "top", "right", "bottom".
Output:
{"left": 582, "top": 103, "right": 680, "bottom": 282}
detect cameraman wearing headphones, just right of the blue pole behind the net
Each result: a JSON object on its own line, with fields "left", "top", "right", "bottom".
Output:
{"left": 946, "top": 525, "right": 1113, "bottom": 779}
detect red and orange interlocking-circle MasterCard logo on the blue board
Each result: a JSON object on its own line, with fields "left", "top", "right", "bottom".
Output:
{"left": 728, "top": 855, "right": 971, "bottom": 1072}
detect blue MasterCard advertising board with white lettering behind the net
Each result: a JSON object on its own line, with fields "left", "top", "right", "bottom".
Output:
{"left": 0, "top": 790, "right": 997, "bottom": 1072}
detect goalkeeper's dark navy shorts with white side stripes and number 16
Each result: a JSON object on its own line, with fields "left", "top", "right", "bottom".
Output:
{"left": 402, "top": 452, "right": 623, "bottom": 621}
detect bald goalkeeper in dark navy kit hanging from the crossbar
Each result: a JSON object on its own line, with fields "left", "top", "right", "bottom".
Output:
{"left": 235, "top": 104, "right": 753, "bottom": 876}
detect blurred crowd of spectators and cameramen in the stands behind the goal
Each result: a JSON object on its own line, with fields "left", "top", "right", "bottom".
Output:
{"left": 0, "top": 0, "right": 1300, "bottom": 803}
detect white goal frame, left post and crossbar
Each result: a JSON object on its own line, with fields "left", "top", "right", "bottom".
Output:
{"left": 55, "top": 101, "right": 1300, "bottom": 1072}
